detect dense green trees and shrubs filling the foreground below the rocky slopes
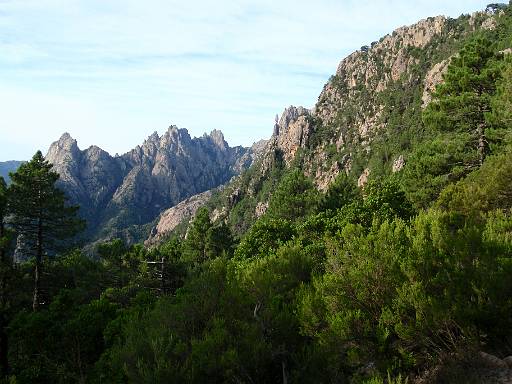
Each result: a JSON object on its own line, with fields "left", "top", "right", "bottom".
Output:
{"left": 0, "top": 5, "right": 512, "bottom": 383}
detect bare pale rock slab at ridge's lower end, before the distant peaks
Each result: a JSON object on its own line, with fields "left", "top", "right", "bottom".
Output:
{"left": 144, "top": 191, "right": 212, "bottom": 246}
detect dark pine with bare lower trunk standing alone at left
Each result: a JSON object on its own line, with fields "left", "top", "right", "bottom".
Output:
{"left": 9, "top": 151, "right": 84, "bottom": 311}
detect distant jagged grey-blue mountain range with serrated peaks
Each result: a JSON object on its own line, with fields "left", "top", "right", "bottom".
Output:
{"left": 46, "top": 126, "right": 257, "bottom": 242}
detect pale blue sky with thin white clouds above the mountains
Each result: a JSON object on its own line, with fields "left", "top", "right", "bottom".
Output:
{"left": 0, "top": 0, "right": 490, "bottom": 161}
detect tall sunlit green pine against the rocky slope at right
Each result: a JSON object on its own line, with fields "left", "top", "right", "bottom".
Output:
{"left": 404, "top": 37, "right": 506, "bottom": 208}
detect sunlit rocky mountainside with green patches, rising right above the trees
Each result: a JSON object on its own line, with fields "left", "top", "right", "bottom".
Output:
{"left": 148, "top": 7, "right": 510, "bottom": 243}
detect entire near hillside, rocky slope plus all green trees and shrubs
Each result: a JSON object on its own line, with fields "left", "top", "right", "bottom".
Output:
{"left": 0, "top": 4, "right": 512, "bottom": 384}
